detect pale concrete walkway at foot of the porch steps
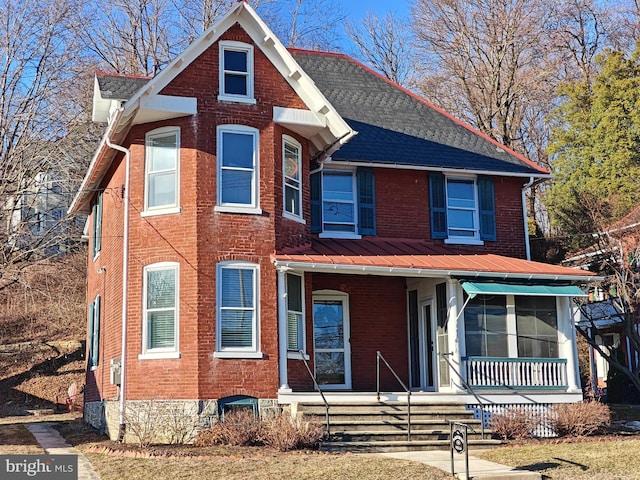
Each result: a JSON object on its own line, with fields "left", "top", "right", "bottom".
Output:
{"left": 381, "top": 450, "right": 542, "bottom": 480}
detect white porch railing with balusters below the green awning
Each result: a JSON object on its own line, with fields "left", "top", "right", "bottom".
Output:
{"left": 462, "top": 357, "right": 569, "bottom": 390}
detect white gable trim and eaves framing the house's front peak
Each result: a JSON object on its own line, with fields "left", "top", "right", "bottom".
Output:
{"left": 69, "top": 1, "right": 355, "bottom": 214}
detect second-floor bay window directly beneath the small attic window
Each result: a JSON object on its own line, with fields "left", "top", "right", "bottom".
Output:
{"left": 216, "top": 125, "right": 260, "bottom": 213}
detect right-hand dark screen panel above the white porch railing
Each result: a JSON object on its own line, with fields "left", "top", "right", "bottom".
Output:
{"left": 516, "top": 296, "right": 558, "bottom": 358}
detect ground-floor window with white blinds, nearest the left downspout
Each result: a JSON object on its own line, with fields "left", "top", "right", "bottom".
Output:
{"left": 141, "top": 262, "right": 179, "bottom": 358}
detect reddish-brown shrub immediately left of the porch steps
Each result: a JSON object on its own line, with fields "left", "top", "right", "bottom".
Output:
{"left": 261, "top": 413, "right": 324, "bottom": 452}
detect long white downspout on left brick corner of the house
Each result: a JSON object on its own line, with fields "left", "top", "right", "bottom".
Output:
{"left": 106, "top": 129, "right": 131, "bottom": 441}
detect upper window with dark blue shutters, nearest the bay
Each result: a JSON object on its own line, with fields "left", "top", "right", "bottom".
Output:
{"left": 311, "top": 168, "right": 376, "bottom": 238}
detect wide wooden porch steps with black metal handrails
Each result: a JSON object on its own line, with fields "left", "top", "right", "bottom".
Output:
{"left": 296, "top": 402, "right": 500, "bottom": 452}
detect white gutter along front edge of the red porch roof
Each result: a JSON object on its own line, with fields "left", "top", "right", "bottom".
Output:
{"left": 272, "top": 260, "right": 603, "bottom": 282}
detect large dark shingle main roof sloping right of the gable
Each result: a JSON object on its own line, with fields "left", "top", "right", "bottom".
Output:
{"left": 291, "top": 50, "right": 544, "bottom": 175}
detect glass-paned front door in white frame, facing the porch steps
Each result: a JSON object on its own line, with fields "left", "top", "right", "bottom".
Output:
{"left": 313, "top": 292, "right": 351, "bottom": 390}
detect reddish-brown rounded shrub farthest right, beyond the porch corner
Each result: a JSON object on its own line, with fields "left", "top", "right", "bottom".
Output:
{"left": 549, "top": 402, "right": 611, "bottom": 437}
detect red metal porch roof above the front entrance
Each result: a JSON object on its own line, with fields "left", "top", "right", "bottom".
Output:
{"left": 271, "top": 238, "right": 597, "bottom": 281}
